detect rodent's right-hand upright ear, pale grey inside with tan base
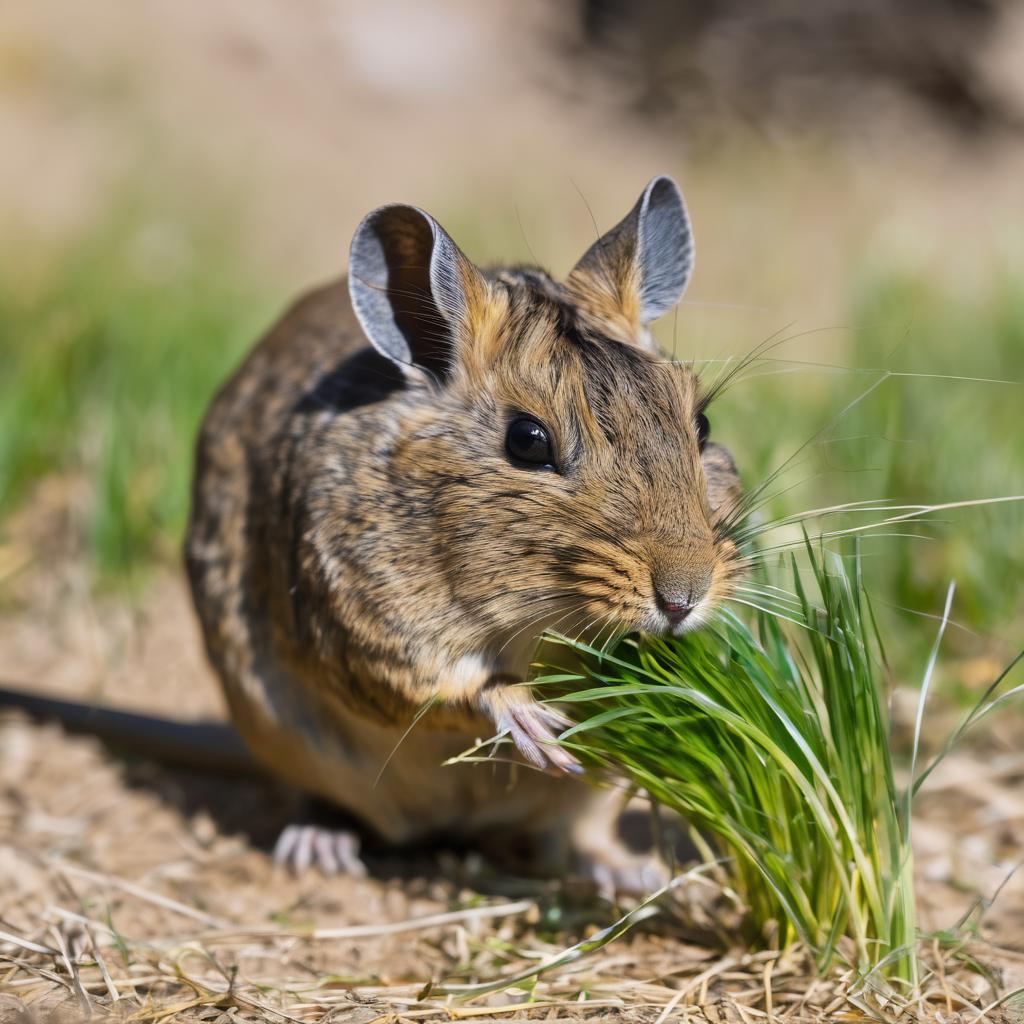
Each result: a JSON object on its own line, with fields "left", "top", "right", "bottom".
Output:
{"left": 567, "top": 174, "right": 693, "bottom": 335}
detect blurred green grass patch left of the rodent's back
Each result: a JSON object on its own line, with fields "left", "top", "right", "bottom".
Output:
{"left": 0, "top": 202, "right": 269, "bottom": 580}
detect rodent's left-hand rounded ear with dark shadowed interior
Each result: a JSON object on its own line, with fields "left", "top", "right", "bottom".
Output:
{"left": 348, "top": 206, "right": 482, "bottom": 376}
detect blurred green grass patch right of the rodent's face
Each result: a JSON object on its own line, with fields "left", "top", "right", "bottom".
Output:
{"left": 704, "top": 267, "right": 1024, "bottom": 664}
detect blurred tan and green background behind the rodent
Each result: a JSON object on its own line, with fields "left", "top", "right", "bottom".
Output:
{"left": 0, "top": 0, "right": 1024, "bottom": 686}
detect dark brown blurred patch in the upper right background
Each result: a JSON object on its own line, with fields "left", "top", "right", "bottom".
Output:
{"left": 580, "top": 0, "right": 1022, "bottom": 129}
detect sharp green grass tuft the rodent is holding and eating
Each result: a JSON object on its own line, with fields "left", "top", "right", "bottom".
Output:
{"left": 535, "top": 547, "right": 916, "bottom": 989}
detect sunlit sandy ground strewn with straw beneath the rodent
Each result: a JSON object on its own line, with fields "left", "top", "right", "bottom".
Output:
{"left": 0, "top": 692, "right": 1024, "bottom": 1024}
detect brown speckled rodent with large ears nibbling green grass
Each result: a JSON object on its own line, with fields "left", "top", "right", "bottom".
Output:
{"left": 185, "top": 175, "right": 743, "bottom": 880}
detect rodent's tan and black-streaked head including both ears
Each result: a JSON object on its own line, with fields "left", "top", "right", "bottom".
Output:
{"left": 349, "top": 176, "right": 742, "bottom": 646}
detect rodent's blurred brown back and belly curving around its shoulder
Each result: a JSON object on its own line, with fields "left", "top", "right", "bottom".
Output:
{"left": 186, "top": 280, "right": 590, "bottom": 842}
